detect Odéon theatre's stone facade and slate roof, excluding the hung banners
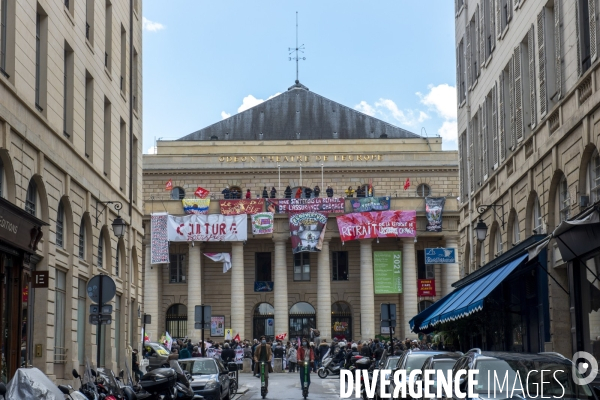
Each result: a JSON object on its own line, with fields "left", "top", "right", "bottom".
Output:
{"left": 144, "top": 82, "right": 458, "bottom": 341}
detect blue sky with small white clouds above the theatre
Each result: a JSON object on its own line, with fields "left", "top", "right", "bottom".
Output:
{"left": 142, "top": 0, "right": 457, "bottom": 153}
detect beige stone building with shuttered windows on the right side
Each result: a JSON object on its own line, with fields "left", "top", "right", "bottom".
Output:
{"left": 455, "top": 0, "right": 600, "bottom": 358}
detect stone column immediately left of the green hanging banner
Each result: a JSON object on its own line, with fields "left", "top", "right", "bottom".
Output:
{"left": 360, "top": 239, "right": 375, "bottom": 339}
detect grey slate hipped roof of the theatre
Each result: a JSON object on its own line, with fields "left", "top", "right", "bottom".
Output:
{"left": 178, "top": 81, "right": 420, "bottom": 140}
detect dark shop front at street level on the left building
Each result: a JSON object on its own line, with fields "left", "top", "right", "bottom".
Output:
{"left": 0, "top": 198, "right": 48, "bottom": 383}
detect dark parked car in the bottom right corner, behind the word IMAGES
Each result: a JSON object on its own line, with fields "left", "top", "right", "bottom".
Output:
{"left": 452, "top": 349, "right": 598, "bottom": 400}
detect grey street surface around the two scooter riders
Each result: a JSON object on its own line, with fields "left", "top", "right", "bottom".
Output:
{"left": 236, "top": 373, "right": 340, "bottom": 400}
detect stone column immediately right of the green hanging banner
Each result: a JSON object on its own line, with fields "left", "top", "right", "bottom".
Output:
{"left": 401, "top": 238, "right": 418, "bottom": 338}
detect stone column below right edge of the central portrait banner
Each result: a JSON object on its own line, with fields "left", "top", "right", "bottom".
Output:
{"left": 317, "top": 238, "right": 332, "bottom": 340}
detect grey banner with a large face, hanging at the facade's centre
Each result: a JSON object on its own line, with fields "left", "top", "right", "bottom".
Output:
{"left": 290, "top": 212, "right": 327, "bottom": 254}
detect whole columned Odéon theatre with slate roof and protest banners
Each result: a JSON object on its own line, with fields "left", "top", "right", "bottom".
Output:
{"left": 143, "top": 82, "right": 460, "bottom": 341}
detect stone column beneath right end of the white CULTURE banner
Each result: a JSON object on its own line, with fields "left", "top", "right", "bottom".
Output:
{"left": 230, "top": 242, "right": 247, "bottom": 339}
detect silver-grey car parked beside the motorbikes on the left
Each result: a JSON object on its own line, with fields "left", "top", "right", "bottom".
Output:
{"left": 179, "top": 357, "right": 231, "bottom": 400}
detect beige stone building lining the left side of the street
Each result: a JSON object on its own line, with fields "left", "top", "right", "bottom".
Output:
{"left": 0, "top": 0, "right": 143, "bottom": 383}
